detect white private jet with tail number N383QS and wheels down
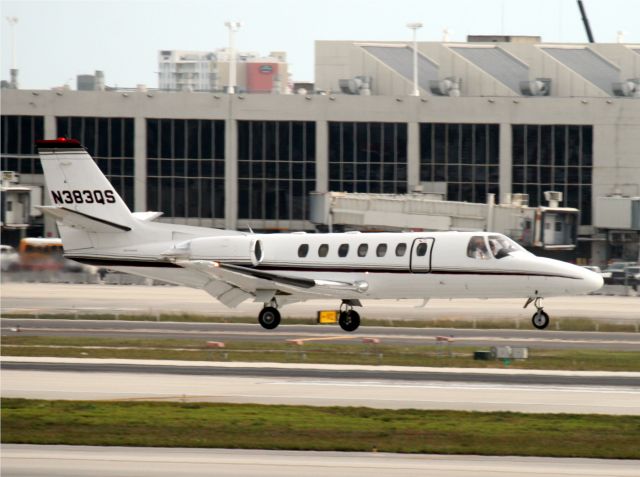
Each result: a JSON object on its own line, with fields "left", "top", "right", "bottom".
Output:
{"left": 36, "top": 138, "right": 603, "bottom": 332}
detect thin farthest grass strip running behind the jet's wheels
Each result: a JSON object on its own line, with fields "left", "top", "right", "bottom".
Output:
{"left": 2, "top": 312, "right": 640, "bottom": 332}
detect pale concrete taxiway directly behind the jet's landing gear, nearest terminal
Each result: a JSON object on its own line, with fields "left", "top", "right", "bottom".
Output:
{"left": 2, "top": 283, "right": 640, "bottom": 324}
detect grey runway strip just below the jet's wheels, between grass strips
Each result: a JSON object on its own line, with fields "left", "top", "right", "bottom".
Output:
{"left": 2, "top": 318, "right": 640, "bottom": 351}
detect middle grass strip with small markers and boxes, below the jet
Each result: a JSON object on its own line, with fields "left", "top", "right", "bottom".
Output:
{"left": 1, "top": 335, "right": 640, "bottom": 371}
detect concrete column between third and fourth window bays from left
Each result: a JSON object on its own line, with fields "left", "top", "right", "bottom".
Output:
{"left": 224, "top": 104, "right": 238, "bottom": 230}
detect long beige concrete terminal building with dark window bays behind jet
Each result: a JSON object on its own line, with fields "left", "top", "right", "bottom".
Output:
{"left": 1, "top": 37, "right": 640, "bottom": 264}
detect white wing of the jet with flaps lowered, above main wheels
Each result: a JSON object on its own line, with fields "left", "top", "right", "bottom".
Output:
{"left": 176, "top": 260, "right": 368, "bottom": 308}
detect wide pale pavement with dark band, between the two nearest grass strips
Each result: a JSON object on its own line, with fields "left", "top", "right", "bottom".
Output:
{"left": 2, "top": 357, "right": 640, "bottom": 415}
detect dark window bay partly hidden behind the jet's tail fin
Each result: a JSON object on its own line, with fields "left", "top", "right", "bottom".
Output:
{"left": 56, "top": 116, "right": 135, "bottom": 210}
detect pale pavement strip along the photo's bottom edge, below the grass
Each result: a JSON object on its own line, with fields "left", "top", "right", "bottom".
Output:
{"left": 1, "top": 444, "right": 640, "bottom": 477}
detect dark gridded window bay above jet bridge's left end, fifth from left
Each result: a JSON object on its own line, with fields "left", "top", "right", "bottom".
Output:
{"left": 329, "top": 122, "right": 407, "bottom": 194}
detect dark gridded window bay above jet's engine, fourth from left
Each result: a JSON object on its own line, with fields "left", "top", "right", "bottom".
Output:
{"left": 238, "top": 121, "right": 316, "bottom": 220}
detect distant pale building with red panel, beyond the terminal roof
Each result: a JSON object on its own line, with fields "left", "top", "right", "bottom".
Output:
{"left": 158, "top": 49, "right": 289, "bottom": 94}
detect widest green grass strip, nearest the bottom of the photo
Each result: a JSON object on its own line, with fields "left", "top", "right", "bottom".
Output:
{"left": 2, "top": 398, "right": 640, "bottom": 459}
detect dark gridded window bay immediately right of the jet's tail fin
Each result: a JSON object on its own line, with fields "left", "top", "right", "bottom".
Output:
{"left": 147, "top": 119, "right": 225, "bottom": 219}
